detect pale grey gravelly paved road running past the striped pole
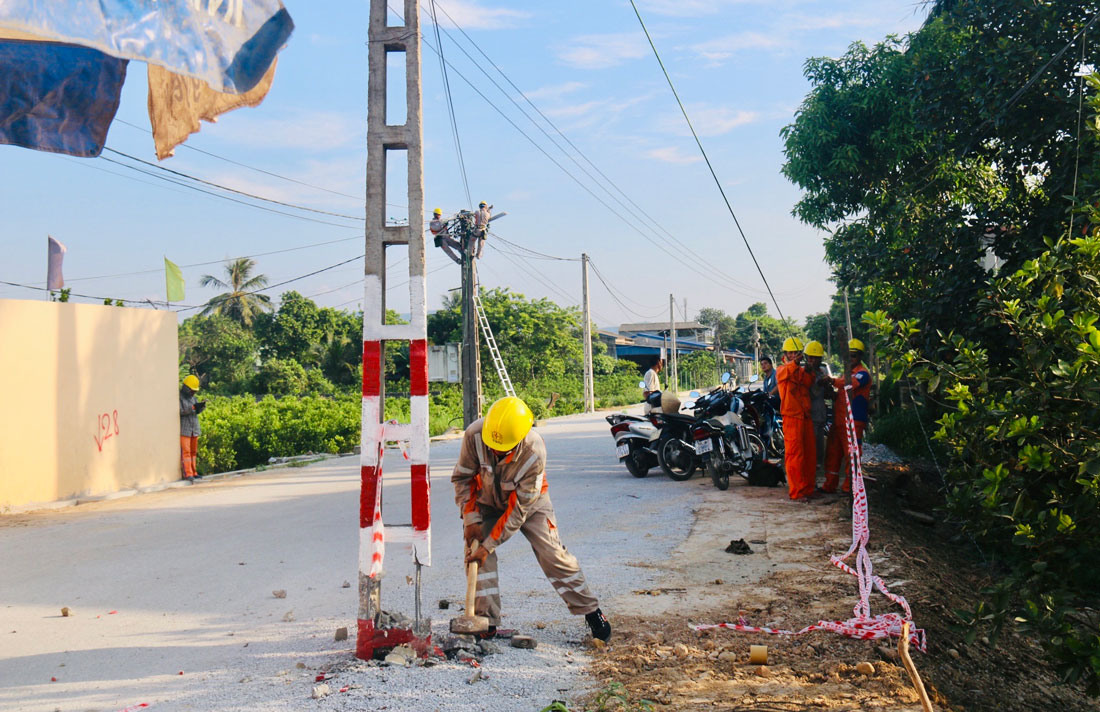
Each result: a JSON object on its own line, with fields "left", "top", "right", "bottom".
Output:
{"left": 0, "top": 415, "right": 702, "bottom": 712}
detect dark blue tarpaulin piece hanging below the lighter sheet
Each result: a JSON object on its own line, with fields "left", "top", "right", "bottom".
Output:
{"left": 0, "top": 41, "right": 127, "bottom": 156}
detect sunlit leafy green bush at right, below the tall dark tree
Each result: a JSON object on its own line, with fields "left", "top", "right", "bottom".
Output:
{"left": 865, "top": 236, "right": 1100, "bottom": 694}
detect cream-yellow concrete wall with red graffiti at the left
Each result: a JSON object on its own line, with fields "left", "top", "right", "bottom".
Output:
{"left": 0, "top": 299, "right": 179, "bottom": 512}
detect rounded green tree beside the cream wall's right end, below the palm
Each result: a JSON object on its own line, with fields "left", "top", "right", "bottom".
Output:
{"left": 179, "top": 315, "right": 260, "bottom": 393}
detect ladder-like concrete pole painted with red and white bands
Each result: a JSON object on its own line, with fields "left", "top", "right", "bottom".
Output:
{"left": 355, "top": 0, "right": 431, "bottom": 660}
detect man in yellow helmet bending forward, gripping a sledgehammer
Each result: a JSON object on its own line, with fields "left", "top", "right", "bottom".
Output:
{"left": 451, "top": 396, "right": 612, "bottom": 642}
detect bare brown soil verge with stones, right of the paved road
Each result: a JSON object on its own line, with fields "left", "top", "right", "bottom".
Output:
{"left": 590, "top": 465, "right": 1098, "bottom": 712}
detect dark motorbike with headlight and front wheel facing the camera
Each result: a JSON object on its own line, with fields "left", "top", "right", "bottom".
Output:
{"left": 688, "top": 373, "right": 778, "bottom": 490}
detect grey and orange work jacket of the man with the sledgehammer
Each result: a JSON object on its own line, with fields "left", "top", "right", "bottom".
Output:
{"left": 451, "top": 418, "right": 549, "bottom": 554}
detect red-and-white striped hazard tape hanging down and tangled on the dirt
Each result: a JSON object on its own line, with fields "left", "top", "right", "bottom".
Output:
{"left": 692, "top": 386, "right": 927, "bottom": 653}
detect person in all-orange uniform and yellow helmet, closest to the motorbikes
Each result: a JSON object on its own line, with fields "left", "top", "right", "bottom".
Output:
{"left": 776, "top": 337, "right": 817, "bottom": 501}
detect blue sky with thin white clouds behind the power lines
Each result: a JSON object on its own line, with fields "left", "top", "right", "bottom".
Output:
{"left": 0, "top": 0, "right": 925, "bottom": 327}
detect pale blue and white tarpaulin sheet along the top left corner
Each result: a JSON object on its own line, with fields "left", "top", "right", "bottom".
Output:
{"left": 0, "top": 0, "right": 294, "bottom": 94}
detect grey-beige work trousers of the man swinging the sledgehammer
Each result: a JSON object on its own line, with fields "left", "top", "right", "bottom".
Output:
{"left": 474, "top": 495, "right": 600, "bottom": 625}
